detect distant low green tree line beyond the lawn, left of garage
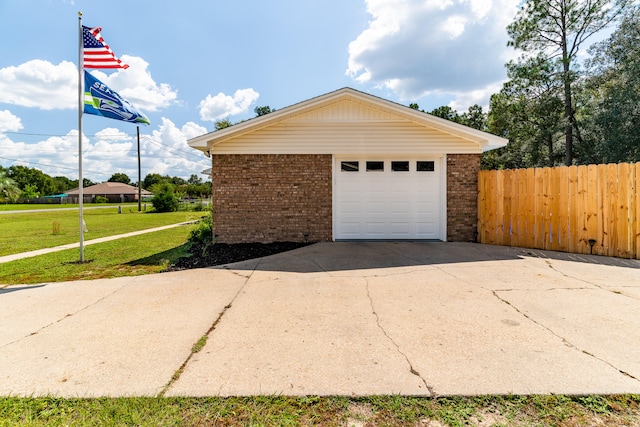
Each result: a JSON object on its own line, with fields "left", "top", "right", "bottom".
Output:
{"left": 0, "top": 166, "right": 211, "bottom": 203}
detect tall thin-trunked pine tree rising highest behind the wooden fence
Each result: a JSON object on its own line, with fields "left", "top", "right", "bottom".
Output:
{"left": 507, "top": 0, "right": 628, "bottom": 165}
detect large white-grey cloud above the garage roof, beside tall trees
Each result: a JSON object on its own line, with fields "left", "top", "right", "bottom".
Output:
{"left": 346, "top": 0, "right": 518, "bottom": 108}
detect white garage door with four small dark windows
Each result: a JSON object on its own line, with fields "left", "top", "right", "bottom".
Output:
{"left": 334, "top": 156, "right": 443, "bottom": 240}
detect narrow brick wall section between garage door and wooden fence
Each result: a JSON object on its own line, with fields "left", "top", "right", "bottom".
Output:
{"left": 447, "top": 154, "right": 480, "bottom": 242}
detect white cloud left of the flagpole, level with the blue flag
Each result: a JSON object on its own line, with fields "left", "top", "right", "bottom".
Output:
{"left": 0, "top": 59, "right": 78, "bottom": 110}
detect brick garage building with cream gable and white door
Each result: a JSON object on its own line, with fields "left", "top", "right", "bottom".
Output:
{"left": 189, "top": 88, "right": 508, "bottom": 243}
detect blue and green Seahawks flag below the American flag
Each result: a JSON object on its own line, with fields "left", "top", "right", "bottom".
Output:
{"left": 84, "top": 70, "right": 151, "bottom": 125}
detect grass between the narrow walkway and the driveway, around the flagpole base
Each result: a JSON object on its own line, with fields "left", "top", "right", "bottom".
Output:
{"left": 0, "top": 226, "right": 191, "bottom": 284}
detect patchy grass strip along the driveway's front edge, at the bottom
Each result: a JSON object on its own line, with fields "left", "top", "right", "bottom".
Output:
{"left": 0, "top": 395, "right": 640, "bottom": 427}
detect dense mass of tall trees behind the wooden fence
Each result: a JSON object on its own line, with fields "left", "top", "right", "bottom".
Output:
{"left": 420, "top": 0, "right": 640, "bottom": 169}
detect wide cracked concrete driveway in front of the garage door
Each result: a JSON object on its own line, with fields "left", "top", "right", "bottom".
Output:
{"left": 0, "top": 242, "right": 640, "bottom": 397}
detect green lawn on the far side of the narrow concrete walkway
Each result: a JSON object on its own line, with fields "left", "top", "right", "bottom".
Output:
{"left": 0, "top": 205, "right": 204, "bottom": 256}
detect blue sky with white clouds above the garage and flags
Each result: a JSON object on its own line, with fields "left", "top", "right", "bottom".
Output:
{"left": 0, "top": 0, "right": 518, "bottom": 182}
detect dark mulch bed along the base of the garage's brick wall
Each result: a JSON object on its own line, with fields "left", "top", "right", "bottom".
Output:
{"left": 166, "top": 242, "right": 309, "bottom": 271}
